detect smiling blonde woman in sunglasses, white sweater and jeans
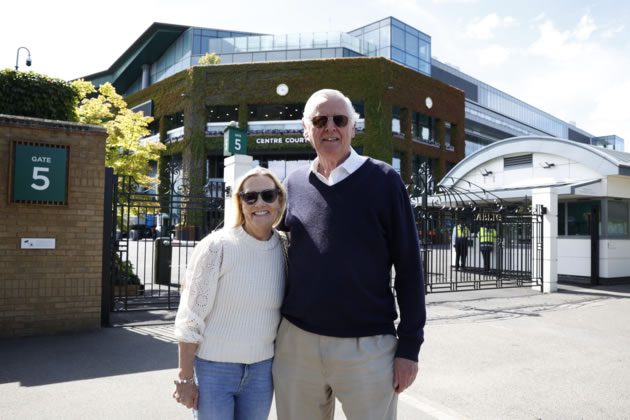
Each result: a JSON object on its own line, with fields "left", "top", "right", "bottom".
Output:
{"left": 173, "top": 167, "right": 286, "bottom": 420}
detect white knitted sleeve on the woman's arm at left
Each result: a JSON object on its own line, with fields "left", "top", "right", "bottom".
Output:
{"left": 175, "top": 236, "right": 223, "bottom": 344}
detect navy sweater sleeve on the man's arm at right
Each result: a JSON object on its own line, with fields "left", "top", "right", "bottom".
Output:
{"left": 388, "top": 172, "right": 426, "bottom": 361}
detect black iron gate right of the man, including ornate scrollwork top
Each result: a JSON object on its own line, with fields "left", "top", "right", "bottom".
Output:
{"left": 411, "top": 163, "right": 543, "bottom": 293}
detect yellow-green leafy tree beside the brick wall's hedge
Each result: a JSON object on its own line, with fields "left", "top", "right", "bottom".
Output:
{"left": 72, "top": 79, "right": 166, "bottom": 188}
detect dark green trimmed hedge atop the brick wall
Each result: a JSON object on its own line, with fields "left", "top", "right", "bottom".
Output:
{"left": 0, "top": 69, "right": 79, "bottom": 121}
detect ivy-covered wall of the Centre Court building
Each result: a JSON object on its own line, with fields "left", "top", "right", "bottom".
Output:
{"left": 126, "top": 57, "right": 465, "bottom": 190}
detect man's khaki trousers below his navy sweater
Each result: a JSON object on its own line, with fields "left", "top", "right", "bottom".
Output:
{"left": 272, "top": 319, "right": 398, "bottom": 420}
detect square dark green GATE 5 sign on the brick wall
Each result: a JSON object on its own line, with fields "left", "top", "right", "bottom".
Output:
{"left": 13, "top": 143, "right": 68, "bottom": 203}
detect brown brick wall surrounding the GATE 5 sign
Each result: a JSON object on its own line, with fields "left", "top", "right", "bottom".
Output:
{"left": 0, "top": 115, "right": 106, "bottom": 337}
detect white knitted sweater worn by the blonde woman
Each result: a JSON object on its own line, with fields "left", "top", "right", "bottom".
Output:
{"left": 175, "top": 227, "right": 285, "bottom": 364}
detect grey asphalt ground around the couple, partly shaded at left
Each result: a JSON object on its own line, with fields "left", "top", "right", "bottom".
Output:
{"left": 0, "top": 285, "right": 630, "bottom": 420}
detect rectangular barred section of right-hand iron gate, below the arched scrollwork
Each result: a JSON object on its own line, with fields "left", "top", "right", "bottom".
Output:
{"left": 418, "top": 208, "right": 543, "bottom": 293}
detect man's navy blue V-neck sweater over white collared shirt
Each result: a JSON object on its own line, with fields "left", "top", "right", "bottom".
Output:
{"left": 282, "top": 158, "right": 426, "bottom": 360}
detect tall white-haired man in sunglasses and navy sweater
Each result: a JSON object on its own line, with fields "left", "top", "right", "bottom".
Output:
{"left": 273, "top": 89, "right": 426, "bottom": 420}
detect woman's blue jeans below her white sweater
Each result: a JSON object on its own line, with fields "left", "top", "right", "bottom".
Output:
{"left": 193, "top": 358, "right": 273, "bottom": 420}
